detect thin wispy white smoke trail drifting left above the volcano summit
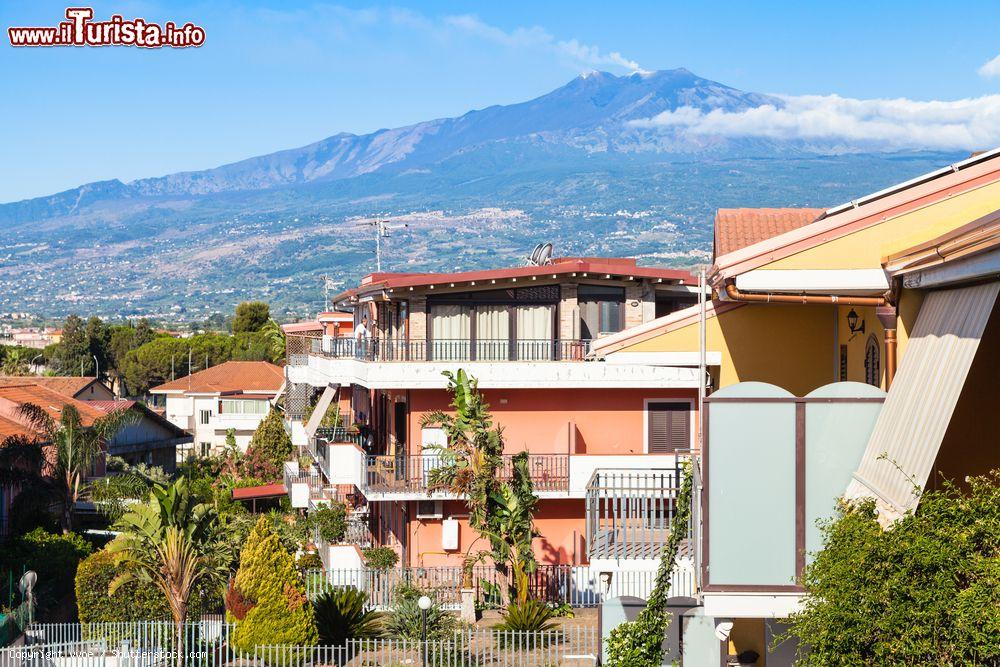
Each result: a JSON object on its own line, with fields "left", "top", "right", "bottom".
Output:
{"left": 444, "top": 14, "right": 645, "bottom": 72}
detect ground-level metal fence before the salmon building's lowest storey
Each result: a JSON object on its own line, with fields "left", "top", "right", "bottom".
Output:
{"left": 306, "top": 558, "right": 697, "bottom": 610}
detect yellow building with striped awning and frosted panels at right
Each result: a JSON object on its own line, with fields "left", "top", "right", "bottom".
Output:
{"left": 594, "top": 149, "right": 1000, "bottom": 667}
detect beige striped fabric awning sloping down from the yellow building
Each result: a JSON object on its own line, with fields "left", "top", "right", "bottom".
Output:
{"left": 845, "top": 281, "right": 1000, "bottom": 523}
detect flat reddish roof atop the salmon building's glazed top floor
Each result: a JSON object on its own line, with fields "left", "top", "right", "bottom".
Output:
{"left": 333, "top": 257, "right": 698, "bottom": 303}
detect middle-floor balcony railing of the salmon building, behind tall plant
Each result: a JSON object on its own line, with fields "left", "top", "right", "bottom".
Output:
{"left": 364, "top": 454, "right": 569, "bottom": 493}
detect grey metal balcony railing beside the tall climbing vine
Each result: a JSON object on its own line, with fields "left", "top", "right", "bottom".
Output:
{"left": 586, "top": 467, "right": 680, "bottom": 558}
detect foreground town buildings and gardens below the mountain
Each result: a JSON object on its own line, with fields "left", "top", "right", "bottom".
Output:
{"left": 0, "top": 148, "right": 1000, "bottom": 667}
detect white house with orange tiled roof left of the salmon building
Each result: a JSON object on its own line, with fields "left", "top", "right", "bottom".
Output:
{"left": 149, "top": 361, "right": 285, "bottom": 456}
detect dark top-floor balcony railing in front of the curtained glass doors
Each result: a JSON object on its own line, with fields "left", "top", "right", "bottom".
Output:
{"left": 287, "top": 335, "right": 591, "bottom": 363}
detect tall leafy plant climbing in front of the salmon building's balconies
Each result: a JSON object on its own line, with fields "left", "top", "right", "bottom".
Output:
{"left": 423, "top": 369, "right": 538, "bottom": 602}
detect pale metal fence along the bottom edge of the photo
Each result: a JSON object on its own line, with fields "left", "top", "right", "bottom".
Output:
{"left": 23, "top": 621, "right": 598, "bottom": 667}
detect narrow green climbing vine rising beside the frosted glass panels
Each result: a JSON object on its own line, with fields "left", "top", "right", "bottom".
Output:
{"left": 605, "top": 462, "right": 694, "bottom": 667}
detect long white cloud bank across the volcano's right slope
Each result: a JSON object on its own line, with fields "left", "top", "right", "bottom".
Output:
{"left": 633, "top": 95, "right": 1000, "bottom": 150}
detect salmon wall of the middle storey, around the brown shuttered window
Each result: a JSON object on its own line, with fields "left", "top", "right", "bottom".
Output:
{"left": 408, "top": 389, "right": 697, "bottom": 454}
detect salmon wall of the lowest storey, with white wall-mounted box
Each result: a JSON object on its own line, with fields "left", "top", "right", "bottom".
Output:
{"left": 409, "top": 499, "right": 587, "bottom": 567}
